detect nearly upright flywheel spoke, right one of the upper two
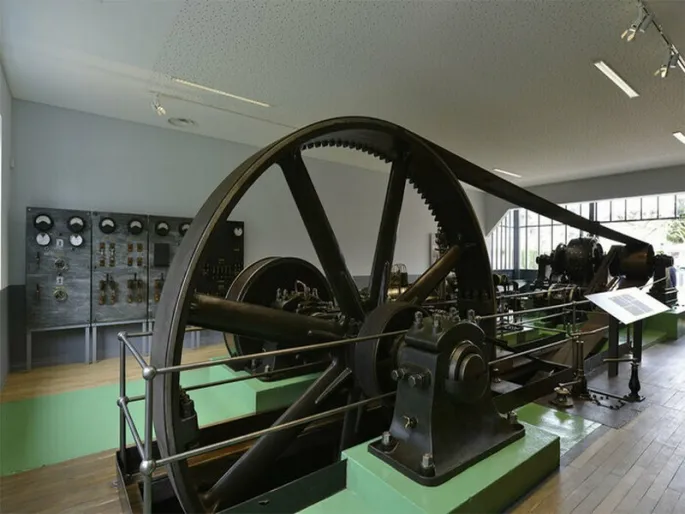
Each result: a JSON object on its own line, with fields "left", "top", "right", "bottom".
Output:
{"left": 369, "top": 151, "right": 408, "bottom": 307}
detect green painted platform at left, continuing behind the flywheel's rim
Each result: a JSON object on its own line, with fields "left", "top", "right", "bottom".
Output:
{"left": 0, "top": 366, "right": 316, "bottom": 476}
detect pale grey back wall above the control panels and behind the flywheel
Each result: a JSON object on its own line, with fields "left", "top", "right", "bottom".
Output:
{"left": 10, "top": 101, "right": 483, "bottom": 284}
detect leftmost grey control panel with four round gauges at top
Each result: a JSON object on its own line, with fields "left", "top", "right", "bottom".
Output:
{"left": 26, "top": 207, "right": 92, "bottom": 329}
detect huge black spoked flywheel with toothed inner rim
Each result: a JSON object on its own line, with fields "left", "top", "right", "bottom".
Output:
{"left": 151, "top": 117, "right": 496, "bottom": 512}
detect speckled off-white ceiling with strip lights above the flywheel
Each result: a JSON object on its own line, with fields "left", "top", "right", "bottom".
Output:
{"left": 0, "top": 0, "right": 685, "bottom": 185}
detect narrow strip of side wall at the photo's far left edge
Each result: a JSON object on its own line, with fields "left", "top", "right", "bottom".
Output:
{"left": 0, "top": 61, "right": 12, "bottom": 388}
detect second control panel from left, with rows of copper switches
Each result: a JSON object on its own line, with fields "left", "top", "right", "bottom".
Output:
{"left": 90, "top": 212, "right": 149, "bottom": 323}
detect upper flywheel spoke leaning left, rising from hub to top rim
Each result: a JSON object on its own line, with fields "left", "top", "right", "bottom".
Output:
{"left": 279, "top": 150, "right": 364, "bottom": 320}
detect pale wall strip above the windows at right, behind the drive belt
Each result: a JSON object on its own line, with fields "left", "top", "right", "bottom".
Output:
{"left": 481, "top": 163, "right": 685, "bottom": 234}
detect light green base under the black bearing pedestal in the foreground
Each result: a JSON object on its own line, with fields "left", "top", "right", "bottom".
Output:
{"left": 301, "top": 424, "right": 560, "bottom": 514}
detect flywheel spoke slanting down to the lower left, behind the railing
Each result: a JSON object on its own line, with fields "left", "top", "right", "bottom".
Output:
{"left": 198, "top": 358, "right": 349, "bottom": 511}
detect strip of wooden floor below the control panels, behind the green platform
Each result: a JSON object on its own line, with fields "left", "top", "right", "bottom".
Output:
{"left": 0, "top": 344, "right": 228, "bottom": 403}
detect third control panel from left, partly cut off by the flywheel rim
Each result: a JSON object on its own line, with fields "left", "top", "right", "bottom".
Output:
{"left": 148, "top": 216, "right": 192, "bottom": 319}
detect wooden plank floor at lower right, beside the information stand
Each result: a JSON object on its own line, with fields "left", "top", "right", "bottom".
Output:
{"left": 512, "top": 338, "right": 685, "bottom": 514}
